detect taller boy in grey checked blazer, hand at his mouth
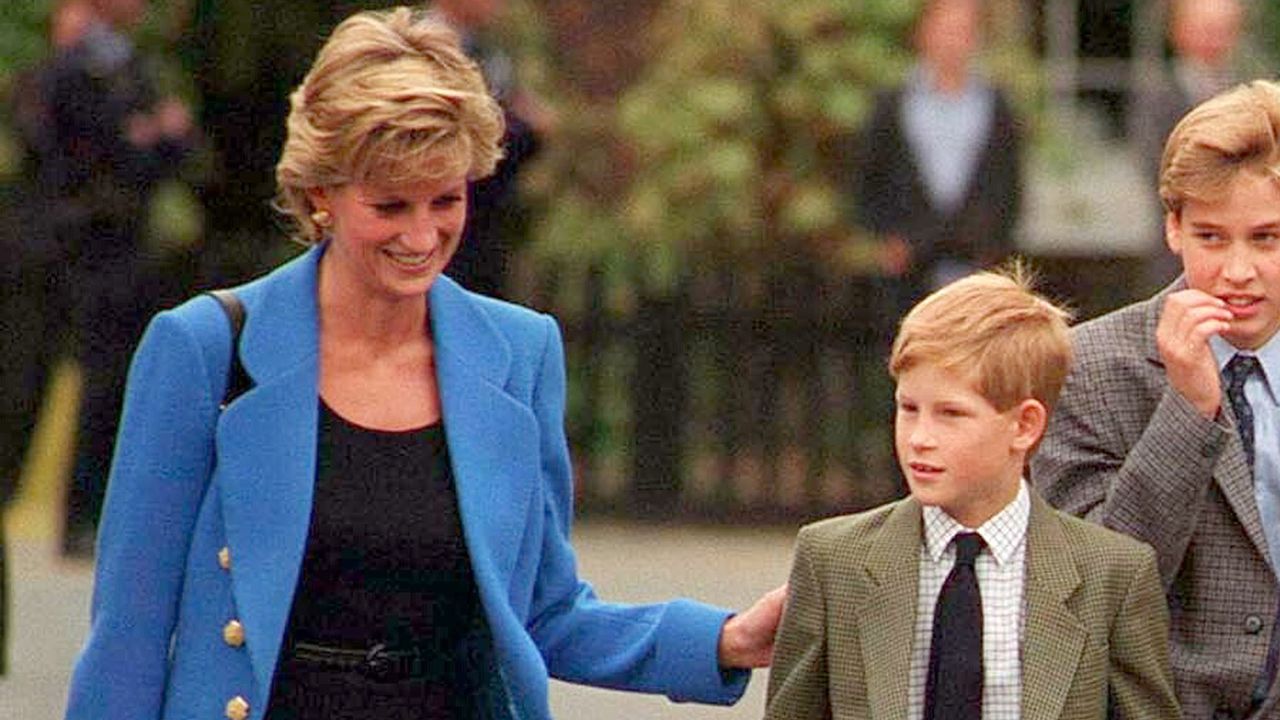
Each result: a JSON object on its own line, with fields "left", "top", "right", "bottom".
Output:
{"left": 1032, "top": 82, "right": 1280, "bottom": 720}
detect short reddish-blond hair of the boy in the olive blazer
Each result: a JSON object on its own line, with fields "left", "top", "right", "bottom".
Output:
{"left": 888, "top": 263, "right": 1071, "bottom": 411}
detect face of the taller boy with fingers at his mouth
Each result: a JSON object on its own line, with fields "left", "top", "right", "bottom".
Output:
{"left": 1165, "top": 170, "right": 1280, "bottom": 350}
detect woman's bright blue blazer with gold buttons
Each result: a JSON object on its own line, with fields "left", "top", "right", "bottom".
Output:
{"left": 68, "top": 247, "right": 749, "bottom": 720}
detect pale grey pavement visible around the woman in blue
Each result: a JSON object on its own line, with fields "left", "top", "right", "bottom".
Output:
{"left": 0, "top": 518, "right": 795, "bottom": 720}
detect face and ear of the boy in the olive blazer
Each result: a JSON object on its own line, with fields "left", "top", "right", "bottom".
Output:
{"left": 893, "top": 363, "right": 1046, "bottom": 528}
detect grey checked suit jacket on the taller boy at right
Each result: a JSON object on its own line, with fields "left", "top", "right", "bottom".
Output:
{"left": 1032, "top": 281, "right": 1280, "bottom": 720}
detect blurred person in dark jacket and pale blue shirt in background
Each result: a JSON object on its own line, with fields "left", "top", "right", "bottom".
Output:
{"left": 850, "top": 0, "right": 1021, "bottom": 316}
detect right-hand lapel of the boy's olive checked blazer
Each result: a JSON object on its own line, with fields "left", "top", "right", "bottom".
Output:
{"left": 1021, "top": 493, "right": 1088, "bottom": 717}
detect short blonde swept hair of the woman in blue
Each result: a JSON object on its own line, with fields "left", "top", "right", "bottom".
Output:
{"left": 275, "top": 8, "right": 504, "bottom": 242}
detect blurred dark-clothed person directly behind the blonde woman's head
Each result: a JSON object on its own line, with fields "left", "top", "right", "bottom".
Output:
{"left": 429, "top": 0, "right": 557, "bottom": 297}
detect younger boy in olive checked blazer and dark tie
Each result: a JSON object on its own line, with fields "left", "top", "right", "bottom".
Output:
{"left": 765, "top": 269, "right": 1180, "bottom": 720}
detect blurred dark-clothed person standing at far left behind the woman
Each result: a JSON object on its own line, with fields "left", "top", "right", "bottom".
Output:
{"left": 37, "top": 0, "right": 195, "bottom": 556}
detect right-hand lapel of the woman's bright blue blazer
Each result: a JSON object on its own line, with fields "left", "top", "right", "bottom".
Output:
{"left": 430, "top": 277, "right": 541, "bottom": 594}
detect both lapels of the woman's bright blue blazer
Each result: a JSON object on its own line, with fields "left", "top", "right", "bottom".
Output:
{"left": 216, "top": 247, "right": 540, "bottom": 692}
